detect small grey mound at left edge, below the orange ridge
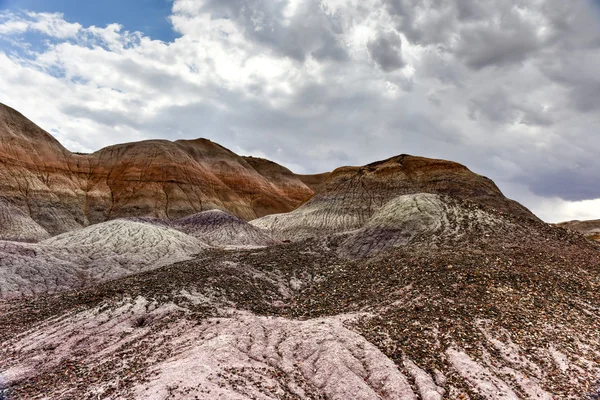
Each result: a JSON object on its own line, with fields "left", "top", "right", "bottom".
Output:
{"left": 0, "top": 199, "right": 50, "bottom": 242}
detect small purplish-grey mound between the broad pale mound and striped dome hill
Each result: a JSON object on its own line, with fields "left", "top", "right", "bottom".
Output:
{"left": 172, "top": 210, "right": 278, "bottom": 246}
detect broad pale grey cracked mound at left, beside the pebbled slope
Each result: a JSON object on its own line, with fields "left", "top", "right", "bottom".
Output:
{"left": 0, "top": 220, "right": 207, "bottom": 298}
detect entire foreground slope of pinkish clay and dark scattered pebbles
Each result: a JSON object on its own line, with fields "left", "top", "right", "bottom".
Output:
{"left": 0, "top": 228, "right": 600, "bottom": 400}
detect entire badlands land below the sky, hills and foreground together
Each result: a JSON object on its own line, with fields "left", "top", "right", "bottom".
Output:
{"left": 0, "top": 105, "right": 600, "bottom": 400}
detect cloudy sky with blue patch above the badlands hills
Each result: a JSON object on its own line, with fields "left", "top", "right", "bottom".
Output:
{"left": 0, "top": 0, "right": 600, "bottom": 221}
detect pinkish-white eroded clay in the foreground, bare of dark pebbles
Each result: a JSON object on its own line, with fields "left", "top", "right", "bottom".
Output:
{"left": 0, "top": 297, "right": 580, "bottom": 400}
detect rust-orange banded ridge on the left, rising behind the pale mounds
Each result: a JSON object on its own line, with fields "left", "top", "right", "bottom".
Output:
{"left": 0, "top": 104, "right": 324, "bottom": 238}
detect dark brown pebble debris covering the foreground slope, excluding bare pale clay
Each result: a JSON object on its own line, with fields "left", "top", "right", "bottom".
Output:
{"left": 0, "top": 211, "right": 600, "bottom": 399}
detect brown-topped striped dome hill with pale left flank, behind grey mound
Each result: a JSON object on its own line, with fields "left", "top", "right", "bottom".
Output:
{"left": 251, "top": 155, "right": 537, "bottom": 240}
